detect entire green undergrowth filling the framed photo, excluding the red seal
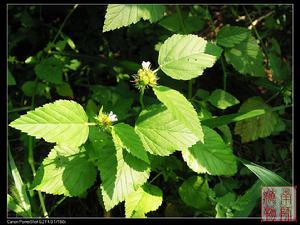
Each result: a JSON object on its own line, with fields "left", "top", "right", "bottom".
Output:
{"left": 7, "top": 5, "right": 293, "bottom": 218}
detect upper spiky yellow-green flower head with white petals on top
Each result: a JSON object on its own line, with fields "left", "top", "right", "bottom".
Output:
{"left": 133, "top": 61, "right": 158, "bottom": 90}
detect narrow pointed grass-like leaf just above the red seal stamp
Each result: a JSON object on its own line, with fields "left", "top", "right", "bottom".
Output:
{"left": 239, "top": 159, "right": 290, "bottom": 186}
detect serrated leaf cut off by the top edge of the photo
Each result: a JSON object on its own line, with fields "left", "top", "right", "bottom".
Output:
{"left": 103, "top": 4, "right": 165, "bottom": 32}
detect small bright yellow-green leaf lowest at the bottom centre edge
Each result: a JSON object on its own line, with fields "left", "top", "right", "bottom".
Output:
{"left": 125, "top": 183, "right": 163, "bottom": 218}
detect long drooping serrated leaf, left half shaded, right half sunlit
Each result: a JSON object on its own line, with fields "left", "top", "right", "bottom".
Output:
{"left": 98, "top": 130, "right": 150, "bottom": 211}
